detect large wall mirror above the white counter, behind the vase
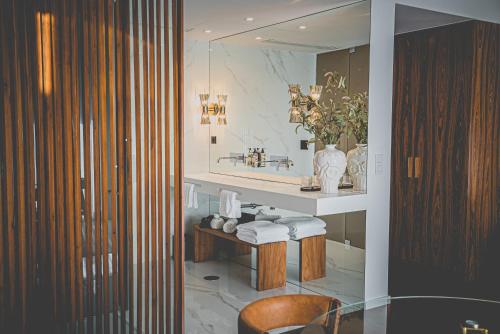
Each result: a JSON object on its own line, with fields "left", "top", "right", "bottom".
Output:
{"left": 208, "top": 1, "right": 370, "bottom": 190}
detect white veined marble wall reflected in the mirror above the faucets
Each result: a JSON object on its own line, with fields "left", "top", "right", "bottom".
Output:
{"left": 210, "top": 41, "right": 316, "bottom": 176}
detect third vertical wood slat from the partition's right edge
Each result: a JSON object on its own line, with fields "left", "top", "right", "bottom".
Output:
{"left": 156, "top": 0, "right": 165, "bottom": 334}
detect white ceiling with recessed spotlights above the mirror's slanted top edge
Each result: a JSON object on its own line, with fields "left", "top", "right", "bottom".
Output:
{"left": 184, "top": 0, "right": 364, "bottom": 41}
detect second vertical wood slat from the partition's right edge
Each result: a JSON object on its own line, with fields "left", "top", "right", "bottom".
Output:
{"left": 163, "top": 1, "right": 172, "bottom": 334}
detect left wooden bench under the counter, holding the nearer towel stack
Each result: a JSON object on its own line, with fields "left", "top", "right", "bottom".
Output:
{"left": 194, "top": 224, "right": 286, "bottom": 291}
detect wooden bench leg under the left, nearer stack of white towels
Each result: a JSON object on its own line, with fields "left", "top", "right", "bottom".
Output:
{"left": 257, "top": 241, "right": 286, "bottom": 291}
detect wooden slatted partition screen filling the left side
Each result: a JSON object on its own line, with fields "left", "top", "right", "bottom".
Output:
{"left": 0, "top": 0, "right": 184, "bottom": 334}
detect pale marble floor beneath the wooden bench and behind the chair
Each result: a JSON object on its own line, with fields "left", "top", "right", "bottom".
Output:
{"left": 185, "top": 241, "right": 365, "bottom": 334}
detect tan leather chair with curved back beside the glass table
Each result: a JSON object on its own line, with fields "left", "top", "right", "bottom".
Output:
{"left": 238, "top": 295, "right": 341, "bottom": 334}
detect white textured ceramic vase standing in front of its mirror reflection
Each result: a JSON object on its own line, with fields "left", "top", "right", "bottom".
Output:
{"left": 313, "top": 145, "right": 347, "bottom": 194}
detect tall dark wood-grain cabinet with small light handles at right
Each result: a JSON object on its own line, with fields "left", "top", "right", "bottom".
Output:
{"left": 390, "top": 21, "right": 500, "bottom": 293}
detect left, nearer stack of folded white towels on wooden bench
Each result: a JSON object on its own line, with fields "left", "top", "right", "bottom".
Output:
{"left": 236, "top": 220, "right": 290, "bottom": 245}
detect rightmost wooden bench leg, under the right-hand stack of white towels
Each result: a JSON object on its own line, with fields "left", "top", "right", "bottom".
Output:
{"left": 299, "top": 235, "right": 326, "bottom": 282}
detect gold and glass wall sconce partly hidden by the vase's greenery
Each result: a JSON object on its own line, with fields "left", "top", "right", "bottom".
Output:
{"left": 288, "top": 84, "right": 323, "bottom": 123}
